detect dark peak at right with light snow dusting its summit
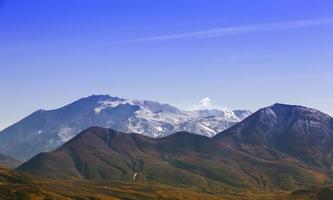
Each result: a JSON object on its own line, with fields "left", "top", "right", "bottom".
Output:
{"left": 214, "top": 104, "right": 333, "bottom": 171}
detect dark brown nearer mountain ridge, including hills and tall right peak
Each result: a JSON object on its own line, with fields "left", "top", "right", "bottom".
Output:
{"left": 18, "top": 104, "right": 333, "bottom": 190}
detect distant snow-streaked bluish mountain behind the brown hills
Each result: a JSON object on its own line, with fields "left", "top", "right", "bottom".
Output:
{"left": 0, "top": 95, "right": 251, "bottom": 160}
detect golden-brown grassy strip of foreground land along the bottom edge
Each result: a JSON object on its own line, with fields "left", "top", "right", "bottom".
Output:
{"left": 0, "top": 167, "right": 333, "bottom": 200}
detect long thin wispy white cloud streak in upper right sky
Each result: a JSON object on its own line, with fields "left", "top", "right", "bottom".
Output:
{"left": 132, "top": 18, "right": 333, "bottom": 42}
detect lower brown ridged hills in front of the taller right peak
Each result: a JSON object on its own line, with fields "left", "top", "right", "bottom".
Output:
{"left": 19, "top": 128, "right": 327, "bottom": 192}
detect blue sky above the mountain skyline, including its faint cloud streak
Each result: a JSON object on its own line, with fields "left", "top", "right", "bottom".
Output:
{"left": 0, "top": 0, "right": 333, "bottom": 130}
